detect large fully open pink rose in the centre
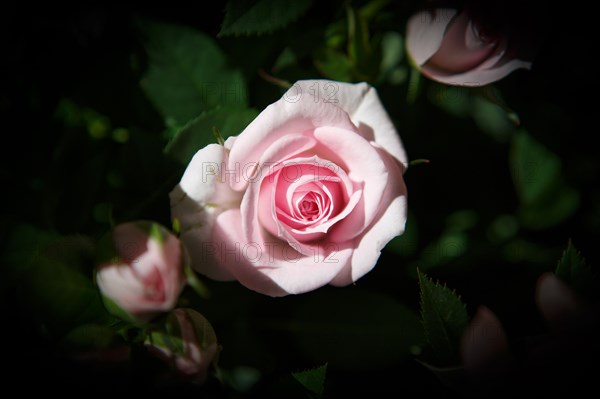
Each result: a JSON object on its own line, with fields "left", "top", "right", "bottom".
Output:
{"left": 171, "top": 80, "right": 407, "bottom": 296}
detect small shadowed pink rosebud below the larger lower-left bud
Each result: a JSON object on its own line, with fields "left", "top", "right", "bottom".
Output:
{"left": 145, "top": 309, "right": 219, "bottom": 384}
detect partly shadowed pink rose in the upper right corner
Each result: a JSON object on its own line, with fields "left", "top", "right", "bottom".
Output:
{"left": 406, "top": 8, "right": 535, "bottom": 86}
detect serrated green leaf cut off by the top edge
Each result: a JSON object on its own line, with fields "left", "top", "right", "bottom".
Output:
{"left": 218, "top": 0, "right": 312, "bottom": 37}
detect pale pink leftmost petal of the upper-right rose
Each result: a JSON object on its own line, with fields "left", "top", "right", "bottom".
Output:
{"left": 406, "top": 8, "right": 457, "bottom": 67}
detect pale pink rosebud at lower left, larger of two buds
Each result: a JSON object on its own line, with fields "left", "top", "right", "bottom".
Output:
{"left": 96, "top": 221, "right": 185, "bottom": 321}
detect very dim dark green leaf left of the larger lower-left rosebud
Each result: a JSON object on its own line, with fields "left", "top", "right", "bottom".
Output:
{"left": 4, "top": 225, "right": 107, "bottom": 336}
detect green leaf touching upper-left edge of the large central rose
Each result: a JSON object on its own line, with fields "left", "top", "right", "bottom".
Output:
{"left": 165, "top": 107, "right": 258, "bottom": 165}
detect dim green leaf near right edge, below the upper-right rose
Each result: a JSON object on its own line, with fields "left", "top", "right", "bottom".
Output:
{"left": 510, "top": 130, "right": 580, "bottom": 229}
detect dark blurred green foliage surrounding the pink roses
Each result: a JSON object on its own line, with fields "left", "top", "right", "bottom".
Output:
{"left": 0, "top": 0, "right": 600, "bottom": 398}
